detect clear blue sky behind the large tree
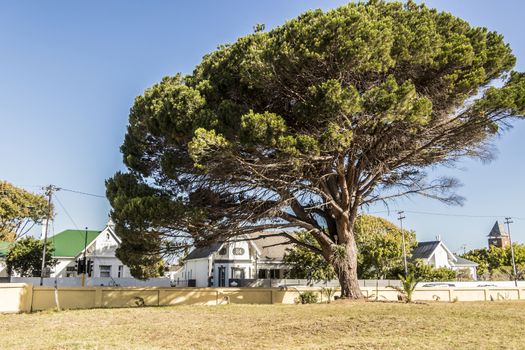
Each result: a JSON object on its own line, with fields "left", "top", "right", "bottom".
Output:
{"left": 0, "top": 0, "right": 525, "bottom": 251}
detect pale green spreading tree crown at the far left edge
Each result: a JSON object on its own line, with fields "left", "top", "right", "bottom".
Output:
{"left": 0, "top": 181, "right": 52, "bottom": 242}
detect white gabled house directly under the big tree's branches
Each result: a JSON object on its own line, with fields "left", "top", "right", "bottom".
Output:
{"left": 173, "top": 236, "right": 291, "bottom": 287}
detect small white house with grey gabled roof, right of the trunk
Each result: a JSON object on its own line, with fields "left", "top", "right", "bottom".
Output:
{"left": 412, "top": 240, "right": 478, "bottom": 280}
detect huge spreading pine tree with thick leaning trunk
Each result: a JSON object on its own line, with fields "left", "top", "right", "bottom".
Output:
{"left": 107, "top": 1, "right": 525, "bottom": 298}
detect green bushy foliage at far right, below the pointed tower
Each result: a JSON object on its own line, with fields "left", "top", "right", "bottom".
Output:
{"left": 462, "top": 243, "right": 525, "bottom": 280}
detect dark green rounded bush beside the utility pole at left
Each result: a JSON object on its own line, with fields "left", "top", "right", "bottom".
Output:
{"left": 5, "top": 237, "right": 56, "bottom": 277}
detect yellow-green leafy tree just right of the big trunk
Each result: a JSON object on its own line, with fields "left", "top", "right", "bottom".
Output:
{"left": 354, "top": 215, "right": 417, "bottom": 279}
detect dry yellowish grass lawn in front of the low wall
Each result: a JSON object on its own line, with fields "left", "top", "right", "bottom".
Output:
{"left": 0, "top": 301, "right": 525, "bottom": 349}
